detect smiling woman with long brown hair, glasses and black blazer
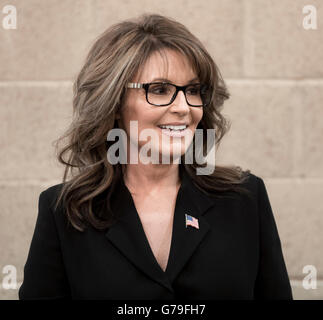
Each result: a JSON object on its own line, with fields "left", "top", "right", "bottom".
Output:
{"left": 19, "top": 15, "right": 292, "bottom": 299}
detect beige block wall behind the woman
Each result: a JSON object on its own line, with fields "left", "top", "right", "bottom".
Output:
{"left": 0, "top": 0, "right": 323, "bottom": 299}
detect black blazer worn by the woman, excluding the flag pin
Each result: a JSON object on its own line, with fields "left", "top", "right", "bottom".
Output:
{"left": 19, "top": 168, "right": 292, "bottom": 300}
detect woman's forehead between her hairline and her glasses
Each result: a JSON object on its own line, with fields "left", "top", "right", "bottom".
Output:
{"left": 135, "top": 49, "right": 196, "bottom": 85}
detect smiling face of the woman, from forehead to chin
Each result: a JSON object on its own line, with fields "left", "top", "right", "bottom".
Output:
{"left": 116, "top": 49, "right": 203, "bottom": 168}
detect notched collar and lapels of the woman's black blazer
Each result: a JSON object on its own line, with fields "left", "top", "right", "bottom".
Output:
{"left": 105, "top": 166, "right": 214, "bottom": 292}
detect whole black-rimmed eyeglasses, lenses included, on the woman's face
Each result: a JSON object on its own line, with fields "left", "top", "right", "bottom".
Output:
{"left": 126, "top": 82, "right": 212, "bottom": 107}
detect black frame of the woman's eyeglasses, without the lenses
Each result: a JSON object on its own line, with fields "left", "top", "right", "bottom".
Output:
{"left": 126, "top": 82, "right": 212, "bottom": 108}
